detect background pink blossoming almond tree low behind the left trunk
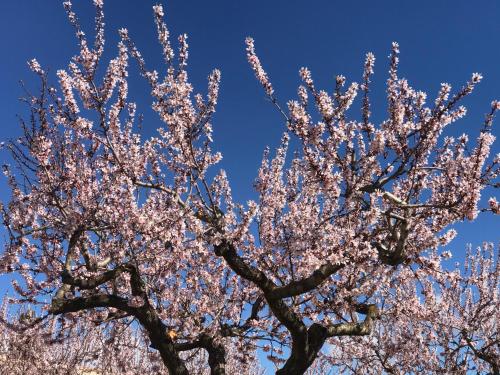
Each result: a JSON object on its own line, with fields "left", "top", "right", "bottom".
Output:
{"left": 0, "top": 300, "right": 263, "bottom": 375}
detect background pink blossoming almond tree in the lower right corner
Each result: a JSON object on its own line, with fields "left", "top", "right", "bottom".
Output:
{"left": 322, "top": 244, "right": 500, "bottom": 374}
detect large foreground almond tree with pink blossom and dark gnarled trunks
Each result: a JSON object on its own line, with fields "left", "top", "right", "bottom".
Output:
{"left": 0, "top": 0, "right": 500, "bottom": 374}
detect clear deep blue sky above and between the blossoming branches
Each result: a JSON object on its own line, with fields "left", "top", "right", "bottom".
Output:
{"left": 0, "top": 0, "right": 500, "bottom": 368}
